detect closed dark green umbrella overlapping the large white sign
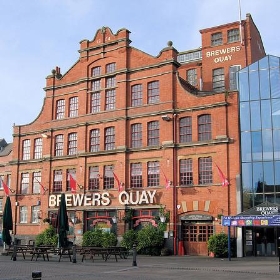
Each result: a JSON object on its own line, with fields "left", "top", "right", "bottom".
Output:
{"left": 56, "top": 193, "right": 69, "bottom": 248}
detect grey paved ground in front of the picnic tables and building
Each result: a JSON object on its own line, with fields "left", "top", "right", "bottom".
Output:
{"left": 0, "top": 255, "right": 280, "bottom": 280}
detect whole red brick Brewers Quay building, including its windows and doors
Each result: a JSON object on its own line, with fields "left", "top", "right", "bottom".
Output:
{"left": 0, "top": 14, "right": 265, "bottom": 255}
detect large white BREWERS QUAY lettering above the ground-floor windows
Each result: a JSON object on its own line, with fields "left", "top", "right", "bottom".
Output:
{"left": 49, "top": 190, "right": 156, "bottom": 207}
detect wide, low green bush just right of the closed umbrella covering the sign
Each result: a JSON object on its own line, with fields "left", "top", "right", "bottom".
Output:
{"left": 82, "top": 228, "right": 118, "bottom": 247}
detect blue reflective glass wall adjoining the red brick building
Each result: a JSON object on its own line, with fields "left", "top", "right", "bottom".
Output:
{"left": 237, "top": 55, "right": 280, "bottom": 211}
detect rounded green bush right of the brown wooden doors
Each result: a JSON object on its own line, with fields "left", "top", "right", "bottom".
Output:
{"left": 207, "top": 233, "right": 236, "bottom": 258}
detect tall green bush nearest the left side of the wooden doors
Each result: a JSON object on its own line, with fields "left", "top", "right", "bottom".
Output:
{"left": 137, "top": 224, "right": 164, "bottom": 255}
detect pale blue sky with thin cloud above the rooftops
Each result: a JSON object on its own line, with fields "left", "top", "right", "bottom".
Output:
{"left": 0, "top": 0, "right": 280, "bottom": 142}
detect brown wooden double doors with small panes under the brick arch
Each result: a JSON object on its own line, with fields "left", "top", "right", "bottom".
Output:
{"left": 182, "top": 223, "right": 213, "bottom": 256}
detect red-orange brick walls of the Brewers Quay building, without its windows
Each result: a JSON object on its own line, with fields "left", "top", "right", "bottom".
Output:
{"left": 0, "top": 14, "right": 265, "bottom": 254}
